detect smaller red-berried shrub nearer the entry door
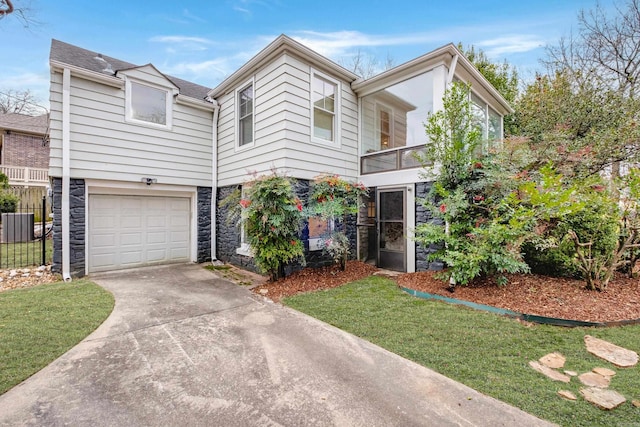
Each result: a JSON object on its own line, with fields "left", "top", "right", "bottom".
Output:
{"left": 307, "top": 175, "right": 368, "bottom": 270}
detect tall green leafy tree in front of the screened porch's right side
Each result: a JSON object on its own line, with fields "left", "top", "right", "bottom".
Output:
{"left": 415, "top": 82, "right": 533, "bottom": 290}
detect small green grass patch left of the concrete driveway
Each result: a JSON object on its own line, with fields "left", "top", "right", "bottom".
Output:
{"left": 0, "top": 280, "right": 114, "bottom": 394}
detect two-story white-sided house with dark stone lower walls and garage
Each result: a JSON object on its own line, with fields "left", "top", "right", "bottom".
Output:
{"left": 50, "top": 35, "right": 511, "bottom": 275}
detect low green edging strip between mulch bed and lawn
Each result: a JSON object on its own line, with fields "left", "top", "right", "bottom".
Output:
{"left": 398, "top": 286, "right": 640, "bottom": 328}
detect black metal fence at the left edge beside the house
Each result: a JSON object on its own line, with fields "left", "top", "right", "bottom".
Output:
{"left": 0, "top": 197, "right": 53, "bottom": 269}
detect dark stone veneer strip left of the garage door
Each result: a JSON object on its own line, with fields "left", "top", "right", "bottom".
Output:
{"left": 51, "top": 178, "right": 86, "bottom": 277}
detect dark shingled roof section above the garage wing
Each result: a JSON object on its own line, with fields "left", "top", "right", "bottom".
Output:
{"left": 49, "top": 39, "right": 209, "bottom": 100}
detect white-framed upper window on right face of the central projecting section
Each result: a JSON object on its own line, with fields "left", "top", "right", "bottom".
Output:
{"left": 311, "top": 73, "right": 339, "bottom": 143}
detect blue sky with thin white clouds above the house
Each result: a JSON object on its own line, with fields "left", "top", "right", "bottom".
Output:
{"left": 0, "top": 0, "right": 613, "bottom": 110}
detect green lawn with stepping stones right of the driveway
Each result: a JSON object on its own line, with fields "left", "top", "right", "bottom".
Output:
{"left": 284, "top": 277, "right": 640, "bottom": 426}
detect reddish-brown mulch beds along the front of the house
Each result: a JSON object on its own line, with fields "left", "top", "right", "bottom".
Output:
{"left": 253, "top": 261, "right": 640, "bottom": 322}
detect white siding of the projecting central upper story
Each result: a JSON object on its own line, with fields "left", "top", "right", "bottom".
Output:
{"left": 217, "top": 54, "right": 358, "bottom": 186}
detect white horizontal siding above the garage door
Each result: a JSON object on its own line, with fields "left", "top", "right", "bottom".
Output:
{"left": 49, "top": 67, "right": 213, "bottom": 186}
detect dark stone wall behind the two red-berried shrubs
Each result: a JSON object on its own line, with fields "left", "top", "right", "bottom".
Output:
{"left": 216, "top": 180, "right": 357, "bottom": 275}
